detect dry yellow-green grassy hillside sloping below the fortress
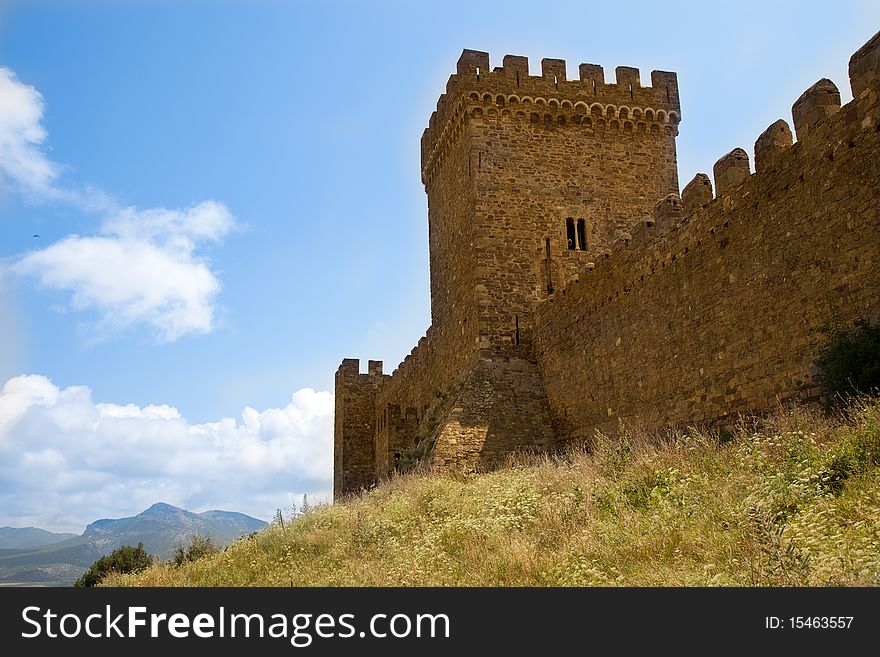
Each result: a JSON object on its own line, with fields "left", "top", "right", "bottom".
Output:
{"left": 109, "top": 400, "right": 880, "bottom": 586}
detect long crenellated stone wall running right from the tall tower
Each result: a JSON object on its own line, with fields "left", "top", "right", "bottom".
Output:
{"left": 535, "top": 59, "right": 880, "bottom": 438}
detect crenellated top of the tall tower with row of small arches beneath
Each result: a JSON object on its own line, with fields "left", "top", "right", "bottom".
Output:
{"left": 422, "top": 50, "right": 681, "bottom": 184}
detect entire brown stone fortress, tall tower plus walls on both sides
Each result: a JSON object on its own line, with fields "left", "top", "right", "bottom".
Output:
{"left": 334, "top": 33, "right": 880, "bottom": 497}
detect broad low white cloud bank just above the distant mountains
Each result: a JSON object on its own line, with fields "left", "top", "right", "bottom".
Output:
{"left": 0, "top": 375, "right": 333, "bottom": 531}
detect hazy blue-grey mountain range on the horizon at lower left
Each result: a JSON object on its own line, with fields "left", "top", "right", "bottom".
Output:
{"left": 0, "top": 502, "right": 267, "bottom": 586}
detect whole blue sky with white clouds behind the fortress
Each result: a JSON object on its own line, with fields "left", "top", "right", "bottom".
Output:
{"left": 0, "top": 0, "right": 880, "bottom": 530}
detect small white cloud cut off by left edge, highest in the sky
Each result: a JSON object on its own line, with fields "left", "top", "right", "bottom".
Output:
{"left": 0, "top": 67, "right": 58, "bottom": 194}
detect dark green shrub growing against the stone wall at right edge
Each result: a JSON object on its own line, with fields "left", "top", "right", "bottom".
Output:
{"left": 816, "top": 319, "right": 880, "bottom": 405}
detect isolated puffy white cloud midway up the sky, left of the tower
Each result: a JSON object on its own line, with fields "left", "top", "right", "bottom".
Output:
{"left": 10, "top": 201, "right": 235, "bottom": 342}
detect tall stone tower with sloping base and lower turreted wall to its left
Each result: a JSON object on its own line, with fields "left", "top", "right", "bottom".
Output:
{"left": 334, "top": 50, "right": 681, "bottom": 496}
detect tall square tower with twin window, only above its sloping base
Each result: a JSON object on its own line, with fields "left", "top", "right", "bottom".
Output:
{"left": 422, "top": 50, "right": 681, "bottom": 355}
